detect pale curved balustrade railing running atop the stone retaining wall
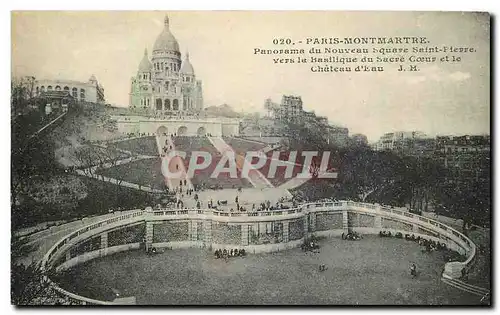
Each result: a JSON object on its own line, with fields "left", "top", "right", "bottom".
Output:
{"left": 42, "top": 201, "right": 476, "bottom": 304}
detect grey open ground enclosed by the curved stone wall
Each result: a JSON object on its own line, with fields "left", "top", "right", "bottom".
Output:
{"left": 53, "top": 236, "right": 479, "bottom": 305}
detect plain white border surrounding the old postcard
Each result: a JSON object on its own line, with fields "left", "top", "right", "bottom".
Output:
{"left": 0, "top": 0, "right": 500, "bottom": 314}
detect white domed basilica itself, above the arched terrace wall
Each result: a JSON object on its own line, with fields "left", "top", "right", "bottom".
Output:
{"left": 129, "top": 16, "right": 203, "bottom": 115}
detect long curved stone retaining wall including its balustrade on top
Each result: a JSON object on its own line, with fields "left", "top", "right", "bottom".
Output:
{"left": 42, "top": 201, "right": 476, "bottom": 304}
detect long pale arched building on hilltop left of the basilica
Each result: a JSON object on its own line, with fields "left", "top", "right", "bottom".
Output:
{"left": 34, "top": 75, "right": 105, "bottom": 104}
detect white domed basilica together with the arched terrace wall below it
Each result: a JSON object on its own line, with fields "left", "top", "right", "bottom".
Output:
{"left": 111, "top": 16, "right": 240, "bottom": 137}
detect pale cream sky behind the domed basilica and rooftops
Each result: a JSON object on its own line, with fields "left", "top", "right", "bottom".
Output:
{"left": 11, "top": 11, "right": 490, "bottom": 141}
